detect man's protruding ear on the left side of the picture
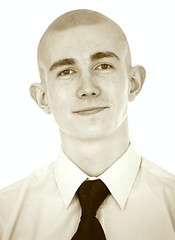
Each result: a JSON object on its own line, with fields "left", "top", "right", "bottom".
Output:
{"left": 30, "top": 83, "right": 51, "bottom": 114}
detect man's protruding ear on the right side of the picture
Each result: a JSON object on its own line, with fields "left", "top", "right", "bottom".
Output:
{"left": 128, "top": 65, "right": 146, "bottom": 101}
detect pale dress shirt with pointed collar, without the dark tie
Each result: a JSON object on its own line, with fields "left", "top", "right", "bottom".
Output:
{"left": 0, "top": 144, "right": 175, "bottom": 240}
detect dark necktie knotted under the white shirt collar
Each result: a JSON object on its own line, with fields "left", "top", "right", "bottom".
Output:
{"left": 72, "top": 179, "right": 109, "bottom": 240}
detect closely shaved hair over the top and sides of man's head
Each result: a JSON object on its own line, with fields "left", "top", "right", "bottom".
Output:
{"left": 37, "top": 9, "right": 131, "bottom": 80}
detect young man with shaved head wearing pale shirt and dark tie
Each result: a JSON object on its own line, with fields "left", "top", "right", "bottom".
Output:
{"left": 0, "top": 10, "right": 175, "bottom": 240}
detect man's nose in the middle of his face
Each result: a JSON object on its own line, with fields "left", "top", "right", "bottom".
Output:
{"left": 76, "top": 77, "right": 100, "bottom": 99}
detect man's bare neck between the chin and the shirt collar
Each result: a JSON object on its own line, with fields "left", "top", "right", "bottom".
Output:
{"left": 61, "top": 119, "right": 129, "bottom": 177}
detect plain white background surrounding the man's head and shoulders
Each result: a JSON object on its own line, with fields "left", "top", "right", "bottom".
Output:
{"left": 0, "top": 0, "right": 175, "bottom": 188}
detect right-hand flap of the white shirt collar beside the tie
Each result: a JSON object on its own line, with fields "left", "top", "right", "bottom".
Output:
{"left": 99, "top": 143, "right": 141, "bottom": 209}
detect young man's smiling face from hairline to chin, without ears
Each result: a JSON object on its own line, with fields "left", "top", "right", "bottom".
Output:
{"left": 41, "top": 23, "right": 129, "bottom": 139}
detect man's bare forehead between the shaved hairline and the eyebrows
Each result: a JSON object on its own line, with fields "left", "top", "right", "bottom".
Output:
{"left": 40, "top": 23, "right": 125, "bottom": 67}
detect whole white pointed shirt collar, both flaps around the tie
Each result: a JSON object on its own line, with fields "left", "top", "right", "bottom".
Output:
{"left": 54, "top": 144, "right": 141, "bottom": 209}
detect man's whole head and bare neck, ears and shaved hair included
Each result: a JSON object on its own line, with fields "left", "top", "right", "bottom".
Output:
{"left": 30, "top": 10, "right": 145, "bottom": 176}
